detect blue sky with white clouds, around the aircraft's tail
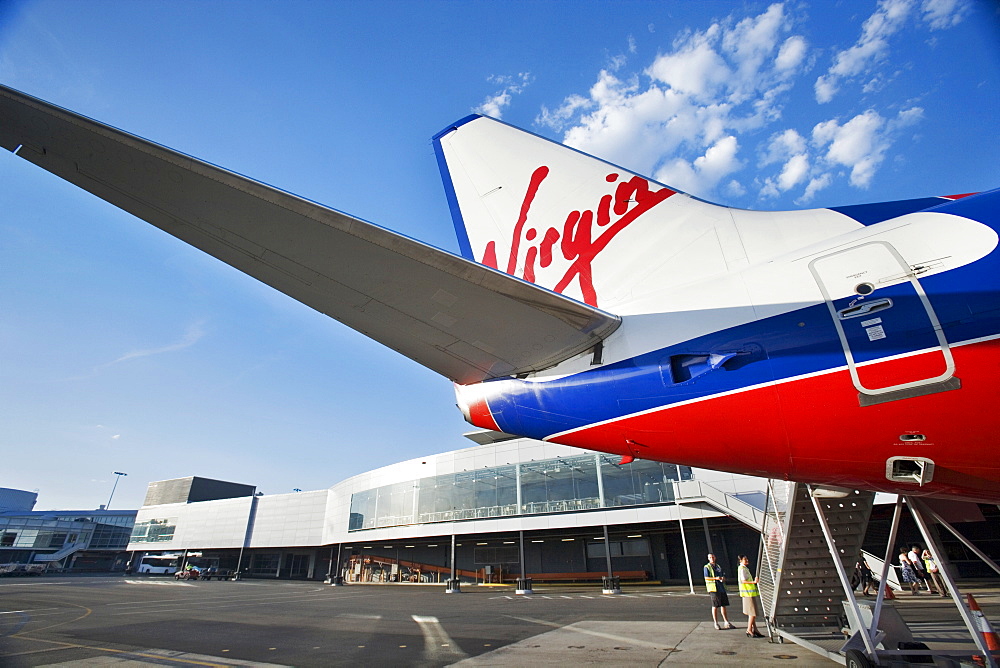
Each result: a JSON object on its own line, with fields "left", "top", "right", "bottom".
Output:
{"left": 0, "top": 0, "right": 1000, "bottom": 509}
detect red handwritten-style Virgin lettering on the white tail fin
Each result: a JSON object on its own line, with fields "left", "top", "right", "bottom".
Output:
{"left": 482, "top": 165, "right": 675, "bottom": 307}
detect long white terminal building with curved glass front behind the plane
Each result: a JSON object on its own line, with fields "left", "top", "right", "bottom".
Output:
{"left": 128, "top": 434, "right": 764, "bottom": 584}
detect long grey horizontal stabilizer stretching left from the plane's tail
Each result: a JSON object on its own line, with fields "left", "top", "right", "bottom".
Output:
{"left": 0, "top": 86, "right": 620, "bottom": 384}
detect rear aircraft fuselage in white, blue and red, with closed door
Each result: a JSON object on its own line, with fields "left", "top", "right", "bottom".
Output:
{"left": 457, "top": 193, "right": 1000, "bottom": 503}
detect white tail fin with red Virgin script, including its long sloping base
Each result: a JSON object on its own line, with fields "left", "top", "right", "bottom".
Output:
{"left": 434, "top": 115, "right": 860, "bottom": 315}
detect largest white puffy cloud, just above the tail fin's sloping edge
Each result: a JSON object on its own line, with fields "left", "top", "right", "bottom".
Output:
{"left": 535, "top": 3, "right": 808, "bottom": 194}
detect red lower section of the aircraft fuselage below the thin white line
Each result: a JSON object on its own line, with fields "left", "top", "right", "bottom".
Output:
{"left": 551, "top": 340, "right": 1000, "bottom": 503}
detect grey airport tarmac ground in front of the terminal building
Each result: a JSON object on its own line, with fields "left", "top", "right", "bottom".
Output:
{"left": 0, "top": 576, "right": 1000, "bottom": 668}
